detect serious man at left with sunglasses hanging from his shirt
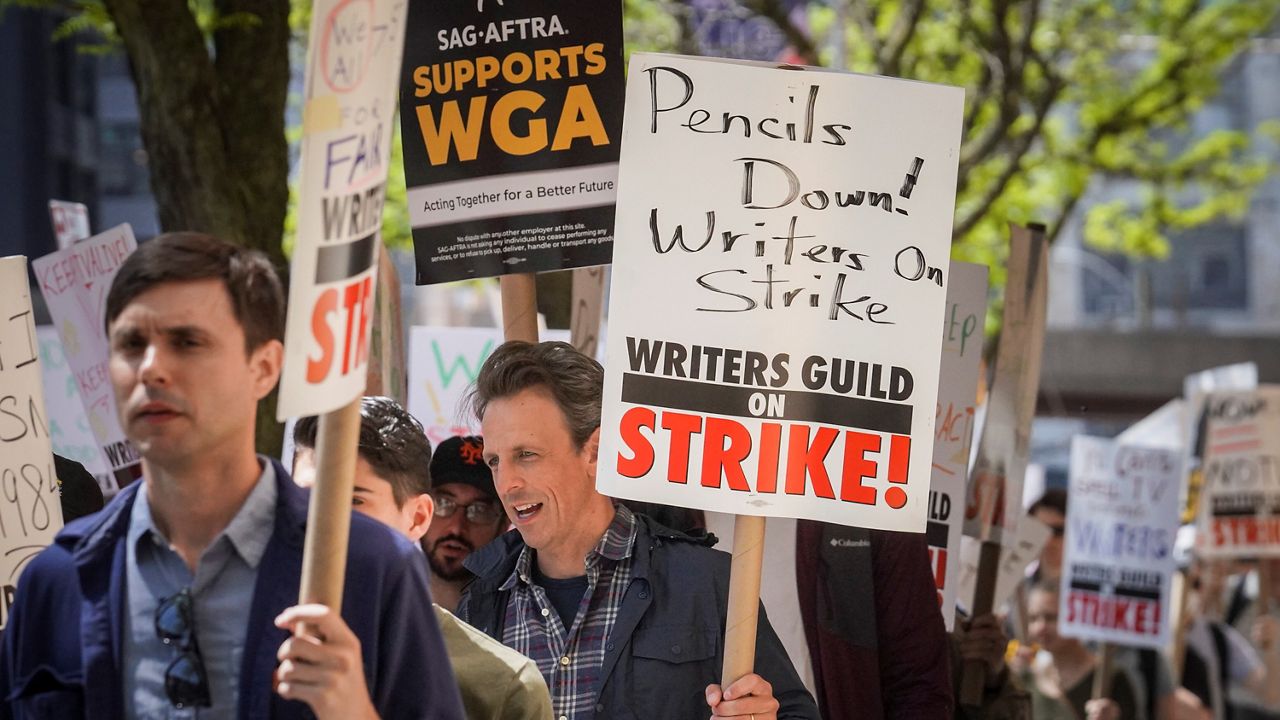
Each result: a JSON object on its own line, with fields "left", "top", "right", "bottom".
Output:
{"left": 0, "top": 233, "right": 462, "bottom": 720}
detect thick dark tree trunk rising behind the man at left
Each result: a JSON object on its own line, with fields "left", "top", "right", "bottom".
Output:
{"left": 105, "top": 0, "right": 289, "bottom": 456}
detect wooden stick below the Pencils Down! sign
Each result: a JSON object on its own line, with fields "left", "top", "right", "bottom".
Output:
{"left": 721, "top": 515, "right": 764, "bottom": 691}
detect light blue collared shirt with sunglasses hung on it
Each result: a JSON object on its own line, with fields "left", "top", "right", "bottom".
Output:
{"left": 122, "top": 457, "right": 276, "bottom": 720}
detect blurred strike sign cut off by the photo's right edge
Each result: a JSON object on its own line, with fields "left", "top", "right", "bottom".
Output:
{"left": 1197, "top": 386, "right": 1280, "bottom": 557}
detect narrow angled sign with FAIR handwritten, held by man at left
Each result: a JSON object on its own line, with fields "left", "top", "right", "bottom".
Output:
{"left": 276, "top": 0, "right": 408, "bottom": 420}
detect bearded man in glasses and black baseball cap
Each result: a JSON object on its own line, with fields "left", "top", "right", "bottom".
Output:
{"left": 422, "top": 436, "right": 507, "bottom": 611}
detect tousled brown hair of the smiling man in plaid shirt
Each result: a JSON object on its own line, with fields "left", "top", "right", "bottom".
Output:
{"left": 467, "top": 340, "right": 604, "bottom": 450}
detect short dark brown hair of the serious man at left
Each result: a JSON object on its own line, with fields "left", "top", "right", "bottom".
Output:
{"left": 105, "top": 232, "right": 284, "bottom": 352}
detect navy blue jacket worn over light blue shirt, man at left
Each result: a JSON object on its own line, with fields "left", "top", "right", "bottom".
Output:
{"left": 0, "top": 461, "right": 463, "bottom": 720}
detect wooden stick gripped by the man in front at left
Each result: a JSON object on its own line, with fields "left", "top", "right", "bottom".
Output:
{"left": 298, "top": 397, "right": 360, "bottom": 610}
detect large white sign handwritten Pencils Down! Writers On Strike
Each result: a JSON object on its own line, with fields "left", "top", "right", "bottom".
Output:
{"left": 598, "top": 54, "right": 964, "bottom": 532}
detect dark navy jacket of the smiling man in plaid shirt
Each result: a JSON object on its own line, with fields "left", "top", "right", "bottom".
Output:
{"left": 458, "top": 514, "right": 818, "bottom": 720}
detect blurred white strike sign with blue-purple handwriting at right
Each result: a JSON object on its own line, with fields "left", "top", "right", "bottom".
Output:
{"left": 1059, "top": 436, "right": 1183, "bottom": 648}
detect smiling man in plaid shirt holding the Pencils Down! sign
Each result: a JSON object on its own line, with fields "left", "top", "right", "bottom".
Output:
{"left": 458, "top": 342, "right": 818, "bottom": 720}
